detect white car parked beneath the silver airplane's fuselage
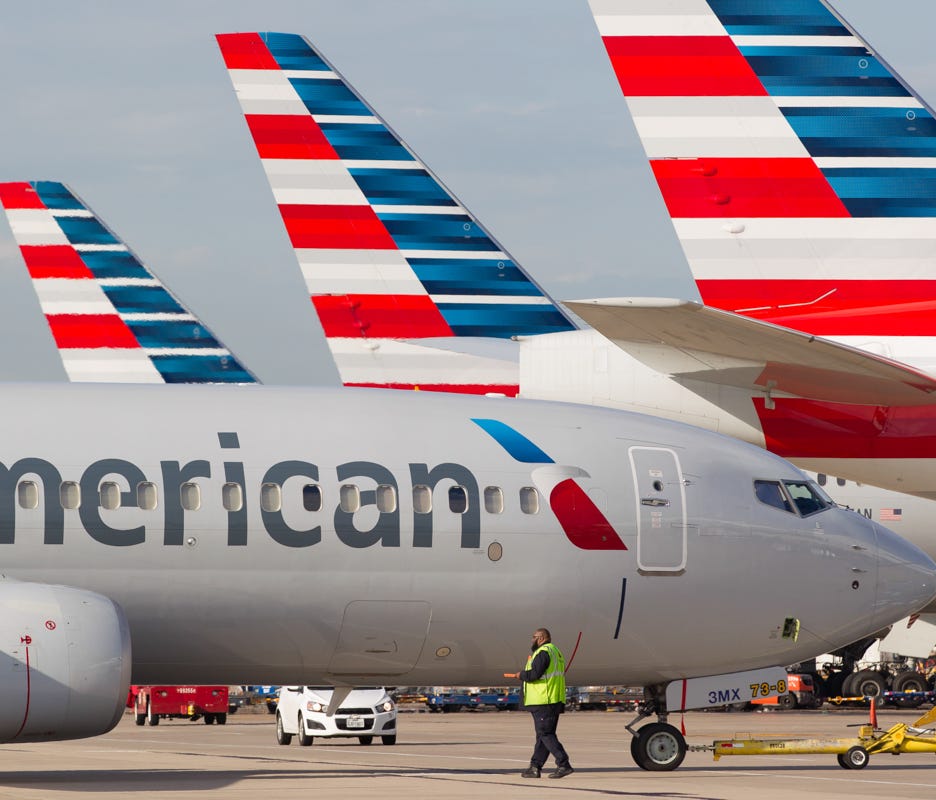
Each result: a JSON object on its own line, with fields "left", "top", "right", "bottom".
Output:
{"left": 276, "top": 686, "right": 396, "bottom": 747}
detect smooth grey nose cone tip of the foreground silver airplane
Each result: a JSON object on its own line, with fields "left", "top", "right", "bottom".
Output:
{"left": 872, "top": 522, "right": 936, "bottom": 627}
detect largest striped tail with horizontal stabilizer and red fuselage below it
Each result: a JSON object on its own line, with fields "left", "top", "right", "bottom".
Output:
{"left": 575, "top": 0, "right": 936, "bottom": 498}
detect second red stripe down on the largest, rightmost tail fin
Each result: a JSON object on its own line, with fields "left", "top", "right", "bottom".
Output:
{"left": 650, "top": 158, "right": 851, "bottom": 218}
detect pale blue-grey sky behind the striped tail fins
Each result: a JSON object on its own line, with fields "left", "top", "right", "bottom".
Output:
{"left": 0, "top": 0, "right": 936, "bottom": 384}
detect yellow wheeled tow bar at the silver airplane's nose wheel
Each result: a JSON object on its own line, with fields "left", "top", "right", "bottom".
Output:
{"left": 690, "top": 701, "right": 936, "bottom": 769}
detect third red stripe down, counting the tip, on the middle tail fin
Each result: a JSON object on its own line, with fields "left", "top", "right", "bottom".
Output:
{"left": 279, "top": 205, "right": 396, "bottom": 250}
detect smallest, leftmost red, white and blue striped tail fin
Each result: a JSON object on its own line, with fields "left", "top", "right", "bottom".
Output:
{"left": 0, "top": 181, "right": 255, "bottom": 383}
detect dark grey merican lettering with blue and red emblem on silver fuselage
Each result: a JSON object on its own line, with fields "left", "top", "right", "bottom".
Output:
{"left": 0, "top": 420, "right": 627, "bottom": 550}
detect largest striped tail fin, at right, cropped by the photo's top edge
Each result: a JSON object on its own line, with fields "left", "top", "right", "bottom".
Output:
{"left": 589, "top": 0, "right": 936, "bottom": 337}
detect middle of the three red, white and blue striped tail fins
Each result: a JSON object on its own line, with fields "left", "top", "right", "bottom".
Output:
{"left": 217, "top": 33, "right": 574, "bottom": 395}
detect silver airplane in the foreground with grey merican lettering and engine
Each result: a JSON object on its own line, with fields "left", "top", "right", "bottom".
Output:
{"left": 0, "top": 383, "right": 936, "bottom": 770}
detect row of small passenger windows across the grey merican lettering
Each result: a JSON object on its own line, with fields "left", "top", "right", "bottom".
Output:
{"left": 16, "top": 481, "right": 540, "bottom": 514}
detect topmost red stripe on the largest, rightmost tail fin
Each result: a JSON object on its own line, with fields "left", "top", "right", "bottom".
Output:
{"left": 602, "top": 36, "right": 767, "bottom": 97}
